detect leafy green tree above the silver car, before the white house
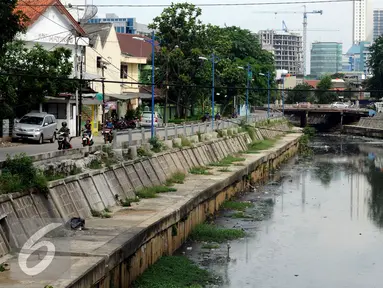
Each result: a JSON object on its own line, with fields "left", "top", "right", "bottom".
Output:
{"left": 0, "top": 41, "right": 78, "bottom": 119}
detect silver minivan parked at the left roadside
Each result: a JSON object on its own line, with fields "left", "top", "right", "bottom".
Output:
{"left": 12, "top": 112, "right": 57, "bottom": 144}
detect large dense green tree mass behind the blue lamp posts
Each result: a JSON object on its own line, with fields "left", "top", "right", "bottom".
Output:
{"left": 150, "top": 3, "right": 275, "bottom": 117}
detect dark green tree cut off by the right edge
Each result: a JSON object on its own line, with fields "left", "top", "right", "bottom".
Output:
{"left": 367, "top": 35, "right": 383, "bottom": 98}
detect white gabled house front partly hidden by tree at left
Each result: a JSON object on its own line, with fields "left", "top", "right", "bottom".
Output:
{"left": 18, "top": 0, "right": 89, "bottom": 135}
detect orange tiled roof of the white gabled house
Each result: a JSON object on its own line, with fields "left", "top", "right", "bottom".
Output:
{"left": 15, "top": 0, "right": 85, "bottom": 35}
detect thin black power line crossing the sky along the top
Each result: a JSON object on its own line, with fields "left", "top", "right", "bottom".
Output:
{"left": 19, "top": 0, "right": 361, "bottom": 8}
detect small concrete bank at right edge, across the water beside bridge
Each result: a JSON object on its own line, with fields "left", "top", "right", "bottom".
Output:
{"left": 342, "top": 114, "right": 383, "bottom": 138}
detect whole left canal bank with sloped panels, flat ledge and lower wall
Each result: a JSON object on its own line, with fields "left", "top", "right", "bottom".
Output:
{"left": 0, "top": 124, "right": 300, "bottom": 288}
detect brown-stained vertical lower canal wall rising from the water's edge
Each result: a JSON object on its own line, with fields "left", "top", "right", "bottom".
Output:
{"left": 62, "top": 135, "right": 299, "bottom": 288}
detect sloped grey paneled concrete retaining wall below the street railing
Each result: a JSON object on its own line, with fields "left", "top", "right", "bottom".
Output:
{"left": 0, "top": 124, "right": 289, "bottom": 257}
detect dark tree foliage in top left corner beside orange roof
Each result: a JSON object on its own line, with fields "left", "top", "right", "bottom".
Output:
{"left": 0, "top": 0, "right": 28, "bottom": 54}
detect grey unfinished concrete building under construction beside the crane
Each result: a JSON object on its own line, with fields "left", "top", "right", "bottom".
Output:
{"left": 258, "top": 30, "right": 303, "bottom": 75}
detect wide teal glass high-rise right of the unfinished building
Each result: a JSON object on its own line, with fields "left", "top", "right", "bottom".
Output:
{"left": 310, "top": 42, "right": 343, "bottom": 77}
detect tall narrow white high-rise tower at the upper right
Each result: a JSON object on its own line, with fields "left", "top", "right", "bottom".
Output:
{"left": 352, "top": 0, "right": 373, "bottom": 44}
